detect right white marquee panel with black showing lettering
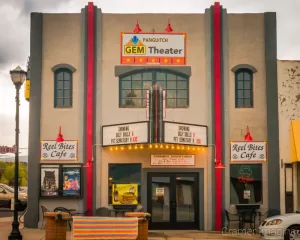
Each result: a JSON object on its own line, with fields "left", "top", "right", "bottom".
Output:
{"left": 164, "top": 122, "right": 208, "bottom": 147}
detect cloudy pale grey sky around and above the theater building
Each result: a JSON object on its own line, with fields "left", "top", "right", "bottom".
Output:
{"left": 0, "top": 0, "right": 300, "bottom": 158}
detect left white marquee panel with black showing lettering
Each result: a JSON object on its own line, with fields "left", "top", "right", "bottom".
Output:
{"left": 102, "top": 122, "right": 149, "bottom": 147}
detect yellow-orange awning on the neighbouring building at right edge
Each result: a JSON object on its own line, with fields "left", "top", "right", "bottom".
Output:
{"left": 290, "top": 120, "right": 300, "bottom": 162}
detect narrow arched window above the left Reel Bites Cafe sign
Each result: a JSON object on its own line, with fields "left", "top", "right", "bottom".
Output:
{"left": 52, "top": 64, "right": 75, "bottom": 108}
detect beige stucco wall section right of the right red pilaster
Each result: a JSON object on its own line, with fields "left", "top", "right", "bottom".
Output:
{"left": 225, "top": 14, "right": 268, "bottom": 211}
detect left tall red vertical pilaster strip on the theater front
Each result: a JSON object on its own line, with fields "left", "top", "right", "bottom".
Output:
{"left": 85, "top": 2, "right": 94, "bottom": 216}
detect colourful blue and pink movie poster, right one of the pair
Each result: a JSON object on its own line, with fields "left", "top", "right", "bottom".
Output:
{"left": 62, "top": 167, "right": 81, "bottom": 196}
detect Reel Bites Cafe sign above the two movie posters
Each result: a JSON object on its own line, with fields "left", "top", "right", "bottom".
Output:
{"left": 41, "top": 141, "right": 78, "bottom": 160}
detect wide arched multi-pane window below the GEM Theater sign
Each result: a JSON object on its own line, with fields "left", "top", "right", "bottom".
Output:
{"left": 119, "top": 69, "right": 189, "bottom": 108}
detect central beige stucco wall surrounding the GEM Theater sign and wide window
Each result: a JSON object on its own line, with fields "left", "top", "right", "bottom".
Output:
{"left": 101, "top": 14, "right": 208, "bottom": 125}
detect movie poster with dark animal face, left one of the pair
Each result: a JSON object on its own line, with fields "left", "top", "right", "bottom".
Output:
{"left": 41, "top": 167, "right": 59, "bottom": 196}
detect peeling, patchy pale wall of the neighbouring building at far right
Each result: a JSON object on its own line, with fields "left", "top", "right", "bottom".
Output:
{"left": 277, "top": 61, "right": 300, "bottom": 212}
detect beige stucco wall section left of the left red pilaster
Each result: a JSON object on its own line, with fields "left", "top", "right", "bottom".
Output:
{"left": 37, "top": 14, "right": 82, "bottom": 223}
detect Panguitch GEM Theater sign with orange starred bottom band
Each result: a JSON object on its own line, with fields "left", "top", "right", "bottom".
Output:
{"left": 121, "top": 33, "right": 186, "bottom": 65}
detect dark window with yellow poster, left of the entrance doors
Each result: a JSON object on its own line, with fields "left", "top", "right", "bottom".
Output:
{"left": 108, "top": 163, "right": 142, "bottom": 205}
